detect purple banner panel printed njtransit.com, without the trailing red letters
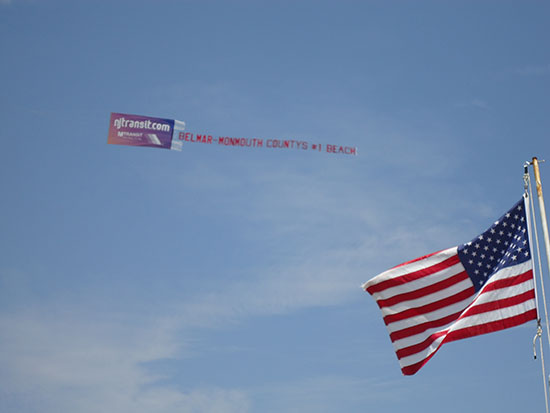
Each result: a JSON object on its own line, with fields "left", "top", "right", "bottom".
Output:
{"left": 107, "top": 113, "right": 177, "bottom": 150}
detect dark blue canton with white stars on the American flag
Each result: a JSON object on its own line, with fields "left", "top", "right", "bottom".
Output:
{"left": 458, "top": 198, "right": 531, "bottom": 292}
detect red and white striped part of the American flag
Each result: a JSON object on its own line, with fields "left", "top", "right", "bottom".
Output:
{"left": 363, "top": 247, "right": 537, "bottom": 375}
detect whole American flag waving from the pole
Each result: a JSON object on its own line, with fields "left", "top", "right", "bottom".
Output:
{"left": 363, "top": 197, "right": 537, "bottom": 375}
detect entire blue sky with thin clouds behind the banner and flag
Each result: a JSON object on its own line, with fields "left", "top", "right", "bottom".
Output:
{"left": 0, "top": 0, "right": 550, "bottom": 413}
